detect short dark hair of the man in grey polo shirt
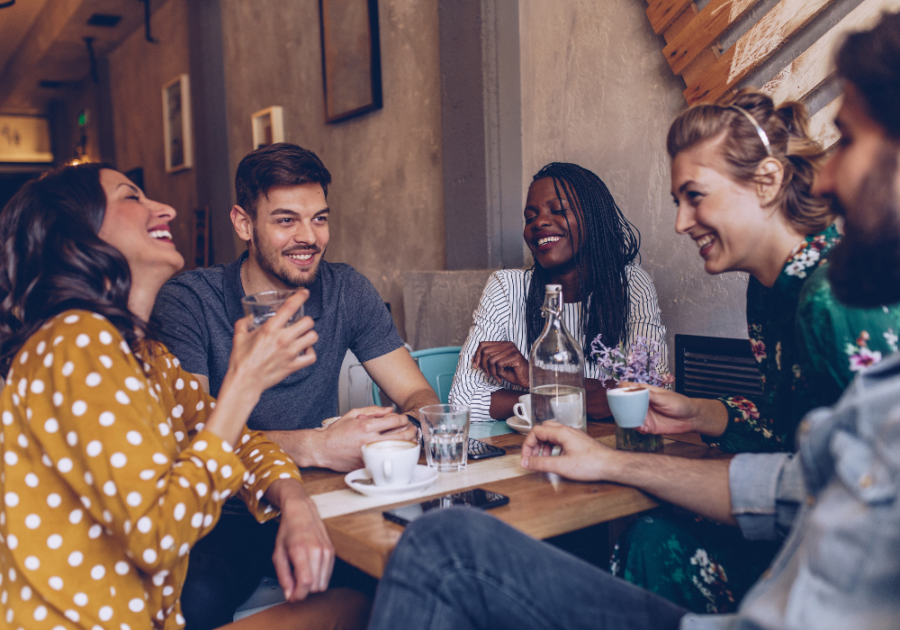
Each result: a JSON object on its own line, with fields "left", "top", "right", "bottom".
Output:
{"left": 234, "top": 142, "right": 331, "bottom": 220}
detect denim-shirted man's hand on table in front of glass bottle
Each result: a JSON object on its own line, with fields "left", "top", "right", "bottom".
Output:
{"left": 522, "top": 421, "right": 618, "bottom": 481}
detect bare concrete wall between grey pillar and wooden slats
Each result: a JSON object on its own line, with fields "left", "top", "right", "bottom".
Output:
{"left": 519, "top": 0, "right": 746, "bottom": 360}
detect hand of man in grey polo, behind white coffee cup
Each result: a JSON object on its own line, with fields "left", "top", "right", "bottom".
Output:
{"left": 315, "top": 407, "right": 418, "bottom": 472}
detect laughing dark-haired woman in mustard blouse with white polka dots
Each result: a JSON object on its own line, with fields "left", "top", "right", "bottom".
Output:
{"left": 0, "top": 165, "right": 365, "bottom": 630}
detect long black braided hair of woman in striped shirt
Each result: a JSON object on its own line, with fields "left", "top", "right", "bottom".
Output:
{"left": 525, "top": 162, "right": 641, "bottom": 354}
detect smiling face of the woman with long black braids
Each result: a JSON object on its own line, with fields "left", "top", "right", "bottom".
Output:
{"left": 522, "top": 177, "right": 578, "bottom": 270}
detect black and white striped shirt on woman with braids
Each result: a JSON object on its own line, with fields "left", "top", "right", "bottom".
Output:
{"left": 450, "top": 265, "right": 668, "bottom": 422}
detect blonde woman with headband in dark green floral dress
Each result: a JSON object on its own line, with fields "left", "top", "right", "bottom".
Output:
{"left": 612, "top": 90, "right": 900, "bottom": 613}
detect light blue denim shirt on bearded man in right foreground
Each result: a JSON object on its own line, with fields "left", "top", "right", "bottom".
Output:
{"left": 681, "top": 354, "right": 900, "bottom": 630}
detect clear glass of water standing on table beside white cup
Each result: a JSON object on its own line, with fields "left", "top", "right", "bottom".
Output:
{"left": 419, "top": 405, "right": 469, "bottom": 472}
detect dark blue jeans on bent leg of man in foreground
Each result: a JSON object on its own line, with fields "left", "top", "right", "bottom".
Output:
{"left": 369, "top": 508, "right": 687, "bottom": 630}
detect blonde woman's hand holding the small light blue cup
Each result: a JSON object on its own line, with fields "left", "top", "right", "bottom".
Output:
{"left": 619, "top": 383, "right": 728, "bottom": 435}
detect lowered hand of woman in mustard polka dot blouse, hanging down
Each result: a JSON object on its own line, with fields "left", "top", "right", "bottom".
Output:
{"left": 266, "top": 479, "right": 334, "bottom": 602}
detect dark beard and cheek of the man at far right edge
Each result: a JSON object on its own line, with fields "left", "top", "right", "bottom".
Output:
{"left": 828, "top": 142, "right": 900, "bottom": 308}
